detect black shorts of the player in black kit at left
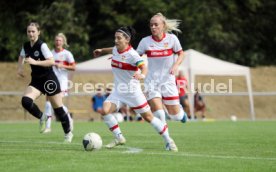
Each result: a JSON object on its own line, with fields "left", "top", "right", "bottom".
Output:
{"left": 29, "top": 73, "right": 61, "bottom": 96}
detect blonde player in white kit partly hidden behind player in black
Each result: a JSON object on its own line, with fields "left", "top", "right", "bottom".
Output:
{"left": 41, "top": 33, "right": 75, "bottom": 133}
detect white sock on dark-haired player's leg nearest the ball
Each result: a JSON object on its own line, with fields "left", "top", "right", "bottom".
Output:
{"left": 103, "top": 114, "right": 122, "bottom": 138}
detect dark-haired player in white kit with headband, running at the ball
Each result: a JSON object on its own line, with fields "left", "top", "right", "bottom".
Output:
{"left": 94, "top": 26, "right": 178, "bottom": 152}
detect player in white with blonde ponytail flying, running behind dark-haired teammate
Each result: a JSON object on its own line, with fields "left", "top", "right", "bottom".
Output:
{"left": 137, "top": 13, "right": 187, "bottom": 123}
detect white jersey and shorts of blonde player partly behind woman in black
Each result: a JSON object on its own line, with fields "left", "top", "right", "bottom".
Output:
{"left": 52, "top": 49, "right": 75, "bottom": 91}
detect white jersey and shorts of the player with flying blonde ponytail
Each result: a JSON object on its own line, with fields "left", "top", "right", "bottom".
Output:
{"left": 137, "top": 33, "right": 182, "bottom": 105}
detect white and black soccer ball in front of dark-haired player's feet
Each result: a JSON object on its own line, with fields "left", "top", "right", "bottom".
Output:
{"left": 82, "top": 132, "right": 103, "bottom": 151}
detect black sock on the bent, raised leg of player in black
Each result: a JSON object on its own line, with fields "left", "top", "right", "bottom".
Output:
{"left": 21, "top": 96, "right": 43, "bottom": 119}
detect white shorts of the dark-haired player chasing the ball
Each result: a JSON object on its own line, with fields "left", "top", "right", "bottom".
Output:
{"left": 105, "top": 90, "right": 150, "bottom": 113}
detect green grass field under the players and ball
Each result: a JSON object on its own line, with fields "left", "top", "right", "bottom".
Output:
{"left": 0, "top": 121, "right": 276, "bottom": 172}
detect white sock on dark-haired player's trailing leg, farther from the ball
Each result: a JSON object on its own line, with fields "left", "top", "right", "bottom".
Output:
{"left": 150, "top": 117, "right": 171, "bottom": 143}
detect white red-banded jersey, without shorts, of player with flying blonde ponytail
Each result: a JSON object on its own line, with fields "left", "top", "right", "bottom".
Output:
{"left": 137, "top": 33, "right": 182, "bottom": 83}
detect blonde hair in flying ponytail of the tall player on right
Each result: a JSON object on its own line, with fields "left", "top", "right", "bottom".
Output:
{"left": 153, "top": 13, "right": 181, "bottom": 33}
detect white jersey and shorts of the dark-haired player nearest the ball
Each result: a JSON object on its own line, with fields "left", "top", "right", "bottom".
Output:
{"left": 106, "top": 46, "right": 150, "bottom": 113}
